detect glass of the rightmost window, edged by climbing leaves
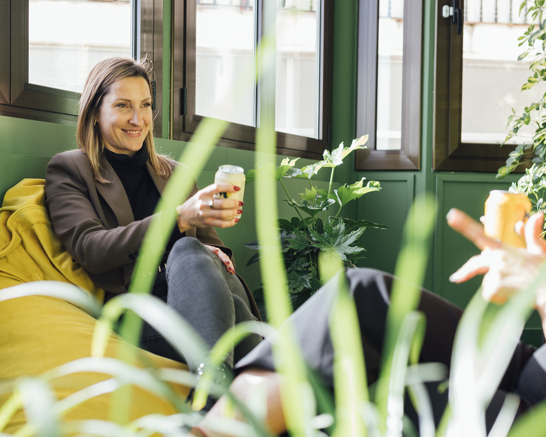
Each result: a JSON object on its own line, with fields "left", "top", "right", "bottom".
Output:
{"left": 461, "top": 0, "right": 544, "bottom": 144}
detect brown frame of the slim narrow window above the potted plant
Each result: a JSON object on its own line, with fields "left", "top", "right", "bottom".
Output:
{"left": 355, "top": 0, "right": 424, "bottom": 171}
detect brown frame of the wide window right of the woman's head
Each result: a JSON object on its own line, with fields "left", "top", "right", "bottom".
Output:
{"left": 172, "top": 0, "right": 333, "bottom": 159}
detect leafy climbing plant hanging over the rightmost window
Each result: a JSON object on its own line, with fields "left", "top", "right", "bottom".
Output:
{"left": 497, "top": 0, "right": 546, "bottom": 228}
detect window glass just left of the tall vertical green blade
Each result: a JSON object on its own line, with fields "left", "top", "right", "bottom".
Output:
{"left": 195, "top": 0, "right": 256, "bottom": 126}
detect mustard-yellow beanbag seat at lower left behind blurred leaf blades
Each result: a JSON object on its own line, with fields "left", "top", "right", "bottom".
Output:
{"left": 0, "top": 296, "right": 188, "bottom": 434}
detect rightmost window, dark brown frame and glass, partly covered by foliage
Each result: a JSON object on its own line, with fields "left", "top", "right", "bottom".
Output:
{"left": 434, "top": 0, "right": 544, "bottom": 172}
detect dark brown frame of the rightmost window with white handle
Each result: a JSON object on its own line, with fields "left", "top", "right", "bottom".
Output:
{"left": 432, "top": 0, "right": 525, "bottom": 173}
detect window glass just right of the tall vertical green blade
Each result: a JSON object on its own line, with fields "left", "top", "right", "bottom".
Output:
{"left": 275, "top": 0, "right": 320, "bottom": 138}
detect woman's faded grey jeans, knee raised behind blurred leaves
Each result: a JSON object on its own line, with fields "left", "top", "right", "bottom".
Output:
{"left": 141, "top": 237, "right": 261, "bottom": 370}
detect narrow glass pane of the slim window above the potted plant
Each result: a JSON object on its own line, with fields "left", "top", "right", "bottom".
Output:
{"left": 376, "top": 0, "right": 404, "bottom": 150}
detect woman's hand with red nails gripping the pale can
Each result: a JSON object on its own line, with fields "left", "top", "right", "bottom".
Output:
{"left": 176, "top": 184, "right": 243, "bottom": 232}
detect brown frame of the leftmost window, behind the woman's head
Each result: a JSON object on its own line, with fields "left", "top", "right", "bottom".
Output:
{"left": 0, "top": 0, "right": 163, "bottom": 137}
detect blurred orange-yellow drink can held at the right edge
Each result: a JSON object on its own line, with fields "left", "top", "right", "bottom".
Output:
{"left": 484, "top": 190, "right": 531, "bottom": 247}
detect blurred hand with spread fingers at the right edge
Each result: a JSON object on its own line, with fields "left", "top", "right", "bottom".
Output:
{"left": 447, "top": 209, "right": 546, "bottom": 304}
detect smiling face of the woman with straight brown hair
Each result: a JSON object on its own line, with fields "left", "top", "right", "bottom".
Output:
{"left": 97, "top": 77, "right": 152, "bottom": 156}
